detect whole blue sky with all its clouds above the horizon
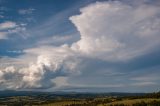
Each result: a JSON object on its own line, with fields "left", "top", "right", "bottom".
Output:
{"left": 0, "top": 0, "right": 160, "bottom": 92}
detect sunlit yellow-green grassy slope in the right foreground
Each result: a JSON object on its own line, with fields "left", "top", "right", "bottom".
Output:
{"left": 38, "top": 98, "right": 160, "bottom": 106}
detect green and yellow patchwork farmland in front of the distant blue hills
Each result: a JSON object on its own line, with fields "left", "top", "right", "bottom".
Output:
{"left": 0, "top": 93, "right": 160, "bottom": 106}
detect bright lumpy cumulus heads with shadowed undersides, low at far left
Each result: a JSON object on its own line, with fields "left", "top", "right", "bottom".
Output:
{"left": 0, "top": 56, "right": 59, "bottom": 89}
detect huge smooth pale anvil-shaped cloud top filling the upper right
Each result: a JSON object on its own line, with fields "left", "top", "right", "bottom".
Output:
{"left": 70, "top": 1, "right": 160, "bottom": 61}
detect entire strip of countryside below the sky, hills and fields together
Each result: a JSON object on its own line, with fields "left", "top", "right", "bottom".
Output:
{"left": 0, "top": 91, "right": 160, "bottom": 106}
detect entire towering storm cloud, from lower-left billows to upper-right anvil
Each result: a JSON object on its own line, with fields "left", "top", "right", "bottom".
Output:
{"left": 0, "top": 1, "right": 160, "bottom": 89}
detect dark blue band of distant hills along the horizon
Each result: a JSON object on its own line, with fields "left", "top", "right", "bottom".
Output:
{"left": 0, "top": 90, "right": 145, "bottom": 98}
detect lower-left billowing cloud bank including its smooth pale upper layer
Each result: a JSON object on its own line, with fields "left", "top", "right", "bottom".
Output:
{"left": 0, "top": 46, "right": 78, "bottom": 89}
